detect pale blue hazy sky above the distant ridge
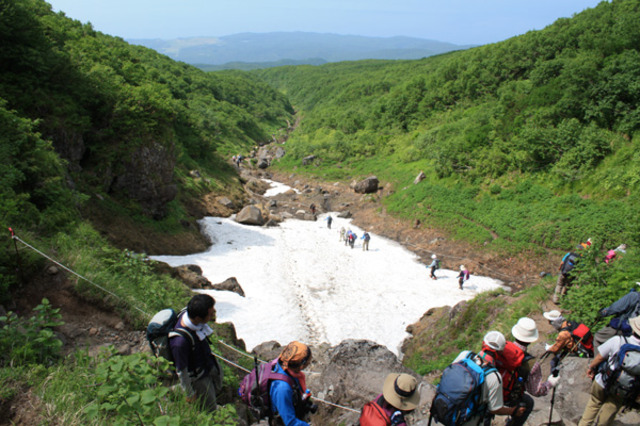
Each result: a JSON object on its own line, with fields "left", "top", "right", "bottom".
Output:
{"left": 48, "top": 0, "right": 600, "bottom": 44}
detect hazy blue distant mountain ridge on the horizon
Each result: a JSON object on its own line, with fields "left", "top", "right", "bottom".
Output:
{"left": 127, "top": 32, "right": 472, "bottom": 65}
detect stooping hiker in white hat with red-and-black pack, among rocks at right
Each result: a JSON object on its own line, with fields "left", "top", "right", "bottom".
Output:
{"left": 542, "top": 310, "right": 593, "bottom": 370}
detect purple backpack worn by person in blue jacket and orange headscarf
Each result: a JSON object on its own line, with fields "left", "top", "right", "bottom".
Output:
{"left": 238, "top": 358, "right": 299, "bottom": 420}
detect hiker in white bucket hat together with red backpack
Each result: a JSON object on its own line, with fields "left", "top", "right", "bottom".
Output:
{"left": 496, "top": 317, "right": 560, "bottom": 426}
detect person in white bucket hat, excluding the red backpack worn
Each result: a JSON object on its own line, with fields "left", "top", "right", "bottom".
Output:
{"left": 501, "top": 317, "right": 559, "bottom": 426}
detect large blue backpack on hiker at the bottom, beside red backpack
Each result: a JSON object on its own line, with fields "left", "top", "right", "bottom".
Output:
{"left": 430, "top": 352, "right": 497, "bottom": 426}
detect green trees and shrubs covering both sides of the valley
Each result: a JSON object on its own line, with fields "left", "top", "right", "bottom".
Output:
{"left": 0, "top": 0, "right": 640, "bottom": 424}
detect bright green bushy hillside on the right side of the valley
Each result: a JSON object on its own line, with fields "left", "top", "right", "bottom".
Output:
{"left": 254, "top": 0, "right": 640, "bottom": 252}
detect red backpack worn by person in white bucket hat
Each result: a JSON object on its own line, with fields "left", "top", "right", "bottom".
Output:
{"left": 496, "top": 342, "right": 533, "bottom": 402}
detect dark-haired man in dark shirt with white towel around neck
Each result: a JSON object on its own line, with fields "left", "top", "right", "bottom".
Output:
{"left": 169, "top": 293, "right": 222, "bottom": 411}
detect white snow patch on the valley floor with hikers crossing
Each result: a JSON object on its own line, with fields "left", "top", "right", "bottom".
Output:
{"left": 152, "top": 183, "right": 501, "bottom": 355}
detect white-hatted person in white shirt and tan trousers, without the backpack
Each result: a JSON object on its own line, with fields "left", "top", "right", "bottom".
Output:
{"left": 578, "top": 317, "right": 640, "bottom": 426}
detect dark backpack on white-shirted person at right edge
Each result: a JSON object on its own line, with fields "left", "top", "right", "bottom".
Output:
{"left": 602, "top": 337, "right": 640, "bottom": 405}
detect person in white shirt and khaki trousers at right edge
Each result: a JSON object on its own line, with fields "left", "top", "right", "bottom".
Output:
{"left": 578, "top": 317, "right": 640, "bottom": 426}
